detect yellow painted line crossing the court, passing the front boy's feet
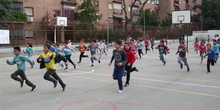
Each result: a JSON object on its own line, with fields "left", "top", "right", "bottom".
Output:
{"left": 63, "top": 74, "right": 220, "bottom": 98}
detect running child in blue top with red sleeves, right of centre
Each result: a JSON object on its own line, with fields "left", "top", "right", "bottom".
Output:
{"left": 156, "top": 40, "right": 170, "bottom": 65}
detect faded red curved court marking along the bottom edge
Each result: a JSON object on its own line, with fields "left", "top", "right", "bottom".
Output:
{"left": 58, "top": 100, "right": 213, "bottom": 110}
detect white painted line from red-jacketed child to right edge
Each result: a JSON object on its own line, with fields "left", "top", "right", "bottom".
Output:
{"left": 132, "top": 73, "right": 220, "bottom": 83}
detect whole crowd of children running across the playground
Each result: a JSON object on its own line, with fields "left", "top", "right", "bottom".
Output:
{"left": 6, "top": 36, "right": 220, "bottom": 93}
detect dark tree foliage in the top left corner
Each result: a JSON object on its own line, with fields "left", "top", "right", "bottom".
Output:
{"left": 0, "top": 0, "right": 11, "bottom": 20}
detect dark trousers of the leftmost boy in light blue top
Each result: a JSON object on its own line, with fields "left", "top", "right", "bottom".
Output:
{"left": 11, "top": 70, "right": 34, "bottom": 87}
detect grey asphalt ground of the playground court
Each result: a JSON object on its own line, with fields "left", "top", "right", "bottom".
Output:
{"left": 0, "top": 43, "right": 220, "bottom": 110}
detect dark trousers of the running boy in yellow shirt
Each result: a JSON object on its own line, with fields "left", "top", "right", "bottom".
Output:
{"left": 44, "top": 69, "right": 65, "bottom": 86}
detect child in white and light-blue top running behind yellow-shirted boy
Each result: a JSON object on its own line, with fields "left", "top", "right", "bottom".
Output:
{"left": 62, "top": 42, "right": 76, "bottom": 69}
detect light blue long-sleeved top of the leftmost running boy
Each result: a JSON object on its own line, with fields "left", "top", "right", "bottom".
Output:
{"left": 7, "top": 54, "right": 34, "bottom": 71}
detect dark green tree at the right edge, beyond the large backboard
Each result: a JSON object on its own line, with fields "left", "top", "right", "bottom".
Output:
{"left": 196, "top": 0, "right": 220, "bottom": 30}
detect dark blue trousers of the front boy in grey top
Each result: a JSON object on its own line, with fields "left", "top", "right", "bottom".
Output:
{"left": 112, "top": 66, "right": 125, "bottom": 90}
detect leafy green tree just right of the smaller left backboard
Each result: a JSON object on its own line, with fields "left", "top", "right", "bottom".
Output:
{"left": 76, "top": 0, "right": 102, "bottom": 23}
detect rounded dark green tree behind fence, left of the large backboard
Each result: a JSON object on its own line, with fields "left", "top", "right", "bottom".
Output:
{"left": 140, "top": 9, "right": 160, "bottom": 26}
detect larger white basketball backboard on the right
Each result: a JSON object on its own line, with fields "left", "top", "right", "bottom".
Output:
{"left": 172, "top": 10, "right": 191, "bottom": 24}
